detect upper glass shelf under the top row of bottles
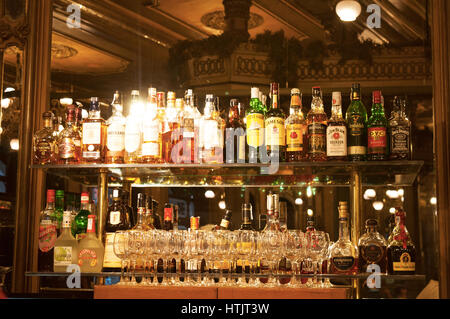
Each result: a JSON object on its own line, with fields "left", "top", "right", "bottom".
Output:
{"left": 31, "top": 161, "right": 424, "bottom": 187}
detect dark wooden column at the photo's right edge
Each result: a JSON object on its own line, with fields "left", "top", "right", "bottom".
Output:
{"left": 431, "top": 0, "right": 450, "bottom": 298}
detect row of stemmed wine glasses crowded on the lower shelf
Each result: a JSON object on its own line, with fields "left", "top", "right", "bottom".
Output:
{"left": 114, "top": 230, "right": 331, "bottom": 287}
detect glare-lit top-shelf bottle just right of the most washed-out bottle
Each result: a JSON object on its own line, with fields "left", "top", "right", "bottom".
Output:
{"left": 141, "top": 88, "right": 162, "bottom": 163}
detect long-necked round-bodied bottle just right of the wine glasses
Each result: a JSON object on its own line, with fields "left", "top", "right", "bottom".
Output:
{"left": 330, "top": 202, "right": 358, "bottom": 275}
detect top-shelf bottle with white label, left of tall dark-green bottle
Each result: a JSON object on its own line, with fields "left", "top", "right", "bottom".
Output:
{"left": 327, "top": 92, "right": 347, "bottom": 161}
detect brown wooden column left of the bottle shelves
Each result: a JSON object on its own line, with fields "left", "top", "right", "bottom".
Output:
{"left": 12, "top": 0, "right": 52, "bottom": 293}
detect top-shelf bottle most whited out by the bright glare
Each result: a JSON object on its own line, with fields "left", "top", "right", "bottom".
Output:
{"left": 125, "top": 90, "right": 143, "bottom": 164}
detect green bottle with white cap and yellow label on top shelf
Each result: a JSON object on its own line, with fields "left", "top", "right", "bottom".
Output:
{"left": 246, "top": 87, "right": 265, "bottom": 163}
